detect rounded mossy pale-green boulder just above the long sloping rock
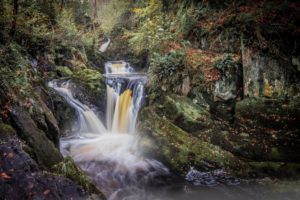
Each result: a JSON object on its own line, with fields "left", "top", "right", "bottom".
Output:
{"left": 155, "top": 95, "right": 212, "bottom": 132}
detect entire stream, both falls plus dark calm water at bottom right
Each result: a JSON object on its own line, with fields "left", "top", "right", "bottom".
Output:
{"left": 49, "top": 61, "right": 300, "bottom": 200}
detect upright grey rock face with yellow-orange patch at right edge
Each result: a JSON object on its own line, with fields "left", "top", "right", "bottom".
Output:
{"left": 242, "top": 48, "right": 300, "bottom": 98}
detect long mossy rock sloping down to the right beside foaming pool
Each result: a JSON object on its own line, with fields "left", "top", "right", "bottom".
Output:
{"left": 138, "top": 107, "right": 243, "bottom": 174}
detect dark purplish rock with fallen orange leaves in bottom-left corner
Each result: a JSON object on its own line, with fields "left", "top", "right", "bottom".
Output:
{"left": 0, "top": 140, "right": 94, "bottom": 199}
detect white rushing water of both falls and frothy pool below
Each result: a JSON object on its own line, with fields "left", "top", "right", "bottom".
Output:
{"left": 49, "top": 62, "right": 169, "bottom": 200}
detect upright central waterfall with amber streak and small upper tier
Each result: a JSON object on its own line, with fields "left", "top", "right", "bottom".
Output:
{"left": 105, "top": 61, "right": 145, "bottom": 133}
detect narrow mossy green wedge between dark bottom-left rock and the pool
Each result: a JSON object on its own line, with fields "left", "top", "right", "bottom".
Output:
{"left": 52, "top": 157, "right": 106, "bottom": 199}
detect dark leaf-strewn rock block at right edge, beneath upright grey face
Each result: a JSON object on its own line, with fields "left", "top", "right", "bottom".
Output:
{"left": 230, "top": 98, "right": 300, "bottom": 162}
